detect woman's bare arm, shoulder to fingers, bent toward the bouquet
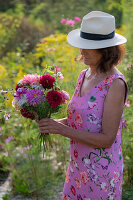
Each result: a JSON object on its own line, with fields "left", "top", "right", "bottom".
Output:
{"left": 39, "top": 79, "right": 125, "bottom": 148}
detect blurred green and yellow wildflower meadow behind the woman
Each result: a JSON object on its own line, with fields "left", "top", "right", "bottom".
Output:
{"left": 0, "top": 0, "right": 133, "bottom": 200}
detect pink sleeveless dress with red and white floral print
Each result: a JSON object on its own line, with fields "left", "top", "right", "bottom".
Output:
{"left": 61, "top": 70, "right": 128, "bottom": 200}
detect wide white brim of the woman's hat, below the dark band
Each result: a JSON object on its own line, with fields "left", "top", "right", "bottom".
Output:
{"left": 67, "top": 29, "right": 127, "bottom": 49}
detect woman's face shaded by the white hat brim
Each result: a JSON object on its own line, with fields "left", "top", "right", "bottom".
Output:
{"left": 80, "top": 49, "right": 102, "bottom": 66}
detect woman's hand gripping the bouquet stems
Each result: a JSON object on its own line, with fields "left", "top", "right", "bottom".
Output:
{"left": 37, "top": 118, "right": 63, "bottom": 134}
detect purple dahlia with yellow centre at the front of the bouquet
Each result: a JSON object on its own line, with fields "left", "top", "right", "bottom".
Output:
{"left": 27, "top": 88, "right": 45, "bottom": 106}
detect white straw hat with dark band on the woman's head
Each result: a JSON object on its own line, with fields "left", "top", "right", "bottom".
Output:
{"left": 67, "top": 11, "right": 127, "bottom": 49}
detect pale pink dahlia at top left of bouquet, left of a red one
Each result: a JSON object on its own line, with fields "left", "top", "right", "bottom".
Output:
{"left": 20, "top": 74, "right": 40, "bottom": 85}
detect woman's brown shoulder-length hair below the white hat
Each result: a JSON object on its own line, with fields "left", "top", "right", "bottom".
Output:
{"left": 78, "top": 45, "right": 126, "bottom": 73}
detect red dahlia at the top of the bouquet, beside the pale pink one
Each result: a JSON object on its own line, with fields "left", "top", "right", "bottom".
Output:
{"left": 39, "top": 74, "right": 55, "bottom": 89}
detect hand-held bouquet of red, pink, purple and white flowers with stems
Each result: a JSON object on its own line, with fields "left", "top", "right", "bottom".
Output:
{"left": 12, "top": 67, "right": 70, "bottom": 155}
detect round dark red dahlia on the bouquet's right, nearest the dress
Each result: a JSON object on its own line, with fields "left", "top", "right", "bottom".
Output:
{"left": 46, "top": 90, "right": 62, "bottom": 108}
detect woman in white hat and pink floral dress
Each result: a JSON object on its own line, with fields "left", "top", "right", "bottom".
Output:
{"left": 38, "top": 11, "right": 128, "bottom": 200}
